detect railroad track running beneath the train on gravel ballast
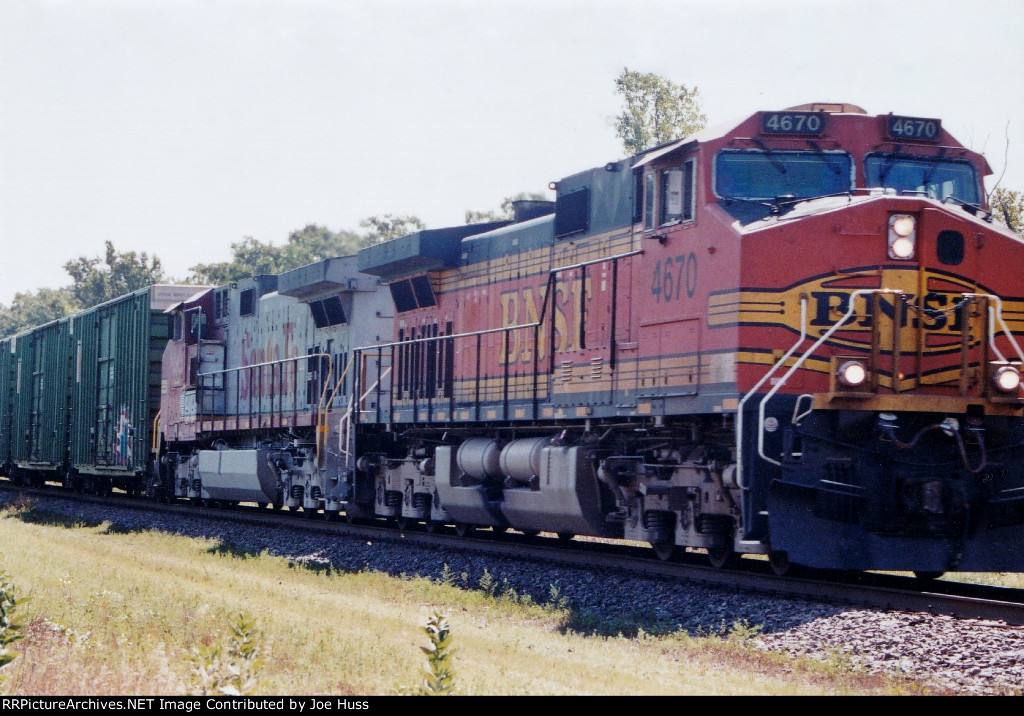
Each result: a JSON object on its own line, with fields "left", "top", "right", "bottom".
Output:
{"left": 8, "top": 481, "right": 1024, "bottom": 625}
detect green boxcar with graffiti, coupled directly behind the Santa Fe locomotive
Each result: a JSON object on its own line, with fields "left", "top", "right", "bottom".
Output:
{"left": 70, "top": 286, "right": 197, "bottom": 492}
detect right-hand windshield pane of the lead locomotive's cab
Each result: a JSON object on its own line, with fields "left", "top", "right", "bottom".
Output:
{"left": 864, "top": 154, "right": 981, "bottom": 204}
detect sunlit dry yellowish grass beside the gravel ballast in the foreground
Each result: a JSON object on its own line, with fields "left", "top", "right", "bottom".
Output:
{"left": 0, "top": 497, "right": 966, "bottom": 696}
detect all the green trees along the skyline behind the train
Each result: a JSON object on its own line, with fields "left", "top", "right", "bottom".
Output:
{"left": 0, "top": 68, "right": 1024, "bottom": 337}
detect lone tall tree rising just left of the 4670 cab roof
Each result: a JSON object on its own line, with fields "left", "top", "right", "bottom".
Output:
{"left": 615, "top": 68, "right": 708, "bottom": 155}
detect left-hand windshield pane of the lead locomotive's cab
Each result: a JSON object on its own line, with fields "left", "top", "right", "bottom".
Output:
{"left": 715, "top": 150, "right": 853, "bottom": 199}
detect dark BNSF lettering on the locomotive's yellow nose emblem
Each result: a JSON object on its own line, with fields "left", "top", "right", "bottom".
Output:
{"left": 810, "top": 291, "right": 962, "bottom": 333}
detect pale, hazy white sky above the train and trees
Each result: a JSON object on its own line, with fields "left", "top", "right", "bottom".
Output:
{"left": 0, "top": 0, "right": 1024, "bottom": 305}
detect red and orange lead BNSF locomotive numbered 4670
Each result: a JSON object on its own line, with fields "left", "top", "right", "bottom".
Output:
{"left": 348, "top": 104, "right": 1024, "bottom": 575}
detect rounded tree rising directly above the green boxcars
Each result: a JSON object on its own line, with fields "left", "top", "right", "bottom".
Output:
{"left": 63, "top": 242, "right": 166, "bottom": 308}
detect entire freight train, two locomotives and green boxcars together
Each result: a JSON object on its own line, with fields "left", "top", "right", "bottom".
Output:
{"left": 0, "top": 104, "right": 1024, "bottom": 576}
